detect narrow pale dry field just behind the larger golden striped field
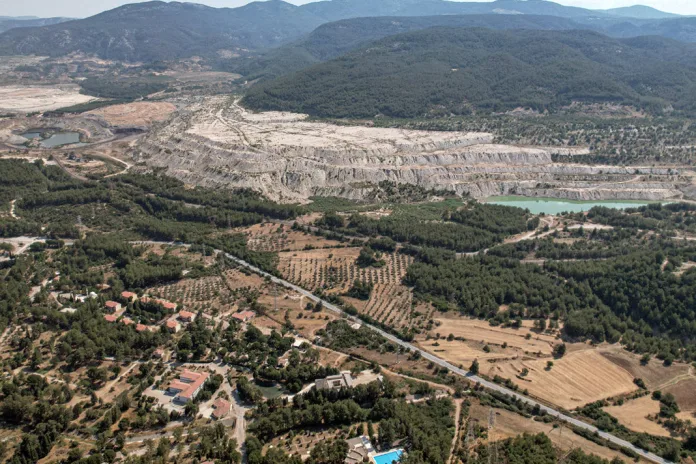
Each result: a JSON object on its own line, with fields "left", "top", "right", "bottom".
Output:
{"left": 431, "top": 314, "right": 560, "bottom": 355}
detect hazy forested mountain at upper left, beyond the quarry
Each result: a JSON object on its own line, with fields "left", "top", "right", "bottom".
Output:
{"left": 0, "top": 0, "right": 325, "bottom": 61}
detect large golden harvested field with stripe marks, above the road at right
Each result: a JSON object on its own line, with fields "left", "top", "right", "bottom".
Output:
{"left": 482, "top": 350, "right": 637, "bottom": 409}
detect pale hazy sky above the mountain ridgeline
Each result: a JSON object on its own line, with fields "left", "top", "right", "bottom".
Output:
{"left": 0, "top": 0, "right": 696, "bottom": 18}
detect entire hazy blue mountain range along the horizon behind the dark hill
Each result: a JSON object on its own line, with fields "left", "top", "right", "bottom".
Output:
{"left": 0, "top": 0, "right": 696, "bottom": 61}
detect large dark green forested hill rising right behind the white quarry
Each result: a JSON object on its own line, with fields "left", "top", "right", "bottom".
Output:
{"left": 244, "top": 28, "right": 696, "bottom": 118}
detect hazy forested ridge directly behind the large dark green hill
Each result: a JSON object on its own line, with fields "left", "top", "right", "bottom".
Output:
{"left": 234, "top": 14, "right": 585, "bottom": 80}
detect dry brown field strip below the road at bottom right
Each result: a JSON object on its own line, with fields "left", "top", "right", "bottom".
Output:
{"left": 469, "top": 403, "right": 640, "bottom": 461}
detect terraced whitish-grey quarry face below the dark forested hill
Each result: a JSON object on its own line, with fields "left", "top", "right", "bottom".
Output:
{"left": 135, "top": 97, "right": 689, "bottom": 202}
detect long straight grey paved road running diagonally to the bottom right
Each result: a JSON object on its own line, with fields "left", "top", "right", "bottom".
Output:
{"left": 220, "top": 253, "right": 672, "bottom": 464}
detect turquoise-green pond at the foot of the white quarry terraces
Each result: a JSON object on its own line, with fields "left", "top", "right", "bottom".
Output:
{"left": 485, "top": 196, "right": 659, "bottom": 215}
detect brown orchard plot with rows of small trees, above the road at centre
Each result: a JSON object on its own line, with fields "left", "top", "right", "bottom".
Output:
{"left": 278, "top": 248, "right": 413, "bottom": 293}
